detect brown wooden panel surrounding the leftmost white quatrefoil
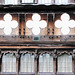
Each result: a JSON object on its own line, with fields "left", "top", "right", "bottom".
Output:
{"left": 0, "top": 13, "right": 19, "bottom": 35}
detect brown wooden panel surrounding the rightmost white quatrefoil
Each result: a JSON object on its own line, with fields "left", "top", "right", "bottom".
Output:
{"left": 54, "top": 13, "right": 75, "bottom": 35}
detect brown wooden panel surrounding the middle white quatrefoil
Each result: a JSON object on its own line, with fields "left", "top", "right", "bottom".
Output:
{"left": 25, "top": 13, "right": 47, "bottom": 36}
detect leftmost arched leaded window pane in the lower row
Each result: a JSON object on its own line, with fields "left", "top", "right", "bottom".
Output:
{"left": 2, "top": 54, "right": 16, "bottom": 72}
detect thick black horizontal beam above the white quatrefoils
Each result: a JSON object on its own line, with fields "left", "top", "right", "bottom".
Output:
{"left": 0, "top": 4, "right": 75, "bottom": 13}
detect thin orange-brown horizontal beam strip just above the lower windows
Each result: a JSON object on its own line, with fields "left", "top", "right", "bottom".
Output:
{"left": 0, "top": 46, "right": 75, "bottom": 49}
